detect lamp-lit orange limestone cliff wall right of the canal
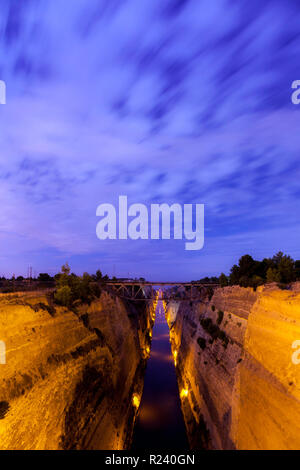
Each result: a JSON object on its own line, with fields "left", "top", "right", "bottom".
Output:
{"left": 167, "top": 284, "right": 300, "bottom": 449}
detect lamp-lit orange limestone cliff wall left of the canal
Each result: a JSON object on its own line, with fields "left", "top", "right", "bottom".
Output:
{"left": 0, "top": 292, "right": 154, "bottom": 449}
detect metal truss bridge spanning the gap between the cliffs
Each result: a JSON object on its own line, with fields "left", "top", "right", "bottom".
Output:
{"left": 105, "top": 281, "right": 219, "bottom": 301}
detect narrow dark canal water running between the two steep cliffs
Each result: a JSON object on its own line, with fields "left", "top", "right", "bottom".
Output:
{"left": 132, "top": 302, "right": 189, "bottom": 450}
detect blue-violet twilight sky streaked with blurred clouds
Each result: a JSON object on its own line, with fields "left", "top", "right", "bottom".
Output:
{"left": 0, "top": 0, "right": 300, "bottom": 280}
